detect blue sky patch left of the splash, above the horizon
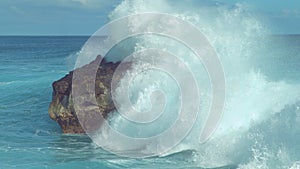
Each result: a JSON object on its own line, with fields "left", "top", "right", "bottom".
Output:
{"left": 0, "top": 0, "right": 120, "bottom": 35}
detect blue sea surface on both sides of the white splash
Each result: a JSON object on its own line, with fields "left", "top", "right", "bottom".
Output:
{"left": 0, "top": 35, "right": 300, "bottom": 169}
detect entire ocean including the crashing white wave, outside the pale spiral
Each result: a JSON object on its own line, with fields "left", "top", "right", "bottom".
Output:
{"left": 0, "top": 0, "right": 300, "bottom": 169}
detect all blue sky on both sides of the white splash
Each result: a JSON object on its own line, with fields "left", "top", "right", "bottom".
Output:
{"left": 0, "top": 0, "right": 300, "bottom": 35}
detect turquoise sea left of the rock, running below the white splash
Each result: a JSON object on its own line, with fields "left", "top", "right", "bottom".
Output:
{"left": 0, "top": 37, "right": 204, "bottom": 169}
